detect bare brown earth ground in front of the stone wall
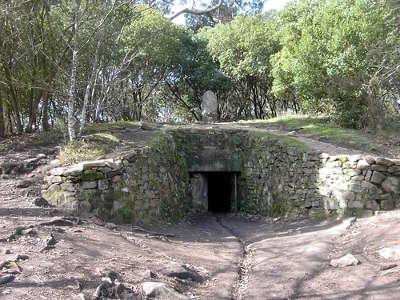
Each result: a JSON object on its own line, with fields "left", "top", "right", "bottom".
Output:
{"left": 0, "top": 123, "right": 400, "bottom": 299}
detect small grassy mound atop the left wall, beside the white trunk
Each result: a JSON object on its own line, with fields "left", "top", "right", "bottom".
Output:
{"left": 58, "top": 132, "right": 120, "bottom": 165}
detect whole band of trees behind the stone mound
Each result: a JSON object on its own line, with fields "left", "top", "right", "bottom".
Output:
{"left": 0, "top": 0, "right": 400, "bottom": 140}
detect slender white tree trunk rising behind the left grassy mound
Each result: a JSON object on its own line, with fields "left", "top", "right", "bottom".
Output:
{"left": 68, "top": 0, "right": 80, "bottom": 141}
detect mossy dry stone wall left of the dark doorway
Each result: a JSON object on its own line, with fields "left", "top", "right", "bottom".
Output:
{"left": 42, "top": 133, "right": 190, "bottom": 223}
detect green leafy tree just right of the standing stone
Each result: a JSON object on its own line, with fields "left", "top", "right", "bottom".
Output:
{"left": 199, "top": 15, "right": 279, "bottom": 118}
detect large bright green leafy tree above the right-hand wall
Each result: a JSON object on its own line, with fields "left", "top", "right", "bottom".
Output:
{"left": 271, "top": 0, "right": 398, "bottom": 128}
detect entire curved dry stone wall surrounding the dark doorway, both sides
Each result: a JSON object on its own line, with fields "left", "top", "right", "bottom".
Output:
{"left": 42, "top": 129, "right": 400, "bottom": 223}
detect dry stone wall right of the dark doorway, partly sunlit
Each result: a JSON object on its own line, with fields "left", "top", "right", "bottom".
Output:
{"left": 242, "top": 138, "right": 400, "bottom": 216}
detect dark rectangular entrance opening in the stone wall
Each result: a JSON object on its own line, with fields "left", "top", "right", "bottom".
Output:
{"left": 205, "top": 172, "right": 237, "bottom": 213}
